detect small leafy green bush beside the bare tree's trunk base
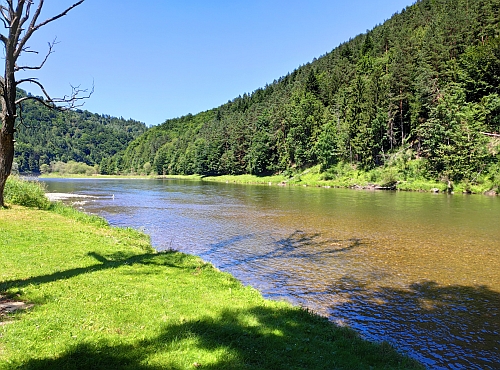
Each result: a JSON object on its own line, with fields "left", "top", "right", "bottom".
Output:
{"left": 4, "top": 176, "right": 50, "bottom": 209}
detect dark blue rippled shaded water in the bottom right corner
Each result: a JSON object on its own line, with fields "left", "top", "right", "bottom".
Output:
{"left": 325, "top": 277, "right": 500, "bottom": 369}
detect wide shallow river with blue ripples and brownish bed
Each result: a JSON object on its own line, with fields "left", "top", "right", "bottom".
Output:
{"left": 44, "top": 179, "right": 500, "bottom": 369}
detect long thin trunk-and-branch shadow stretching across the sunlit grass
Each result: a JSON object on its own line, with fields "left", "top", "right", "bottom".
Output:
{"left": 0, "top": 251, "right": 189, "bottom": 292}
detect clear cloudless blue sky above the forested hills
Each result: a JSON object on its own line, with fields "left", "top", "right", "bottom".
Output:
{"left": 11, "top": 0, "right": 414, "bottom": 125}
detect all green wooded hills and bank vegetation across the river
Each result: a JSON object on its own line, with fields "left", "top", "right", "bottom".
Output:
{"left": 11, "top": 0, "right": 500, "bottom": 194}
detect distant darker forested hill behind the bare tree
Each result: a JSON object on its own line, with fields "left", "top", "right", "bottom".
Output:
{"left": 14, "top": 91, "right": 146, "bottom": 173}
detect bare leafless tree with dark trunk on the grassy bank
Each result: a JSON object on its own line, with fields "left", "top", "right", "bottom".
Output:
{"left": 0, "top": 0, "right": 88, "bottom": 207}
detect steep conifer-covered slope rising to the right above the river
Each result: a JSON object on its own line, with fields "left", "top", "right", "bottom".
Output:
{"left": 114, "top": 0, "right": 500, "bottom": 186}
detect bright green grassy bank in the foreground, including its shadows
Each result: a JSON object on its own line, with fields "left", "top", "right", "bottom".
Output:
{"left": 0, "top": 205, "right": 421, "bottom": 370}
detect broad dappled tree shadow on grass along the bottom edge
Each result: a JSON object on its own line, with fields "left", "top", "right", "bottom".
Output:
{"left": 6, "top": 307, "right": 421, "bottom": 370}
